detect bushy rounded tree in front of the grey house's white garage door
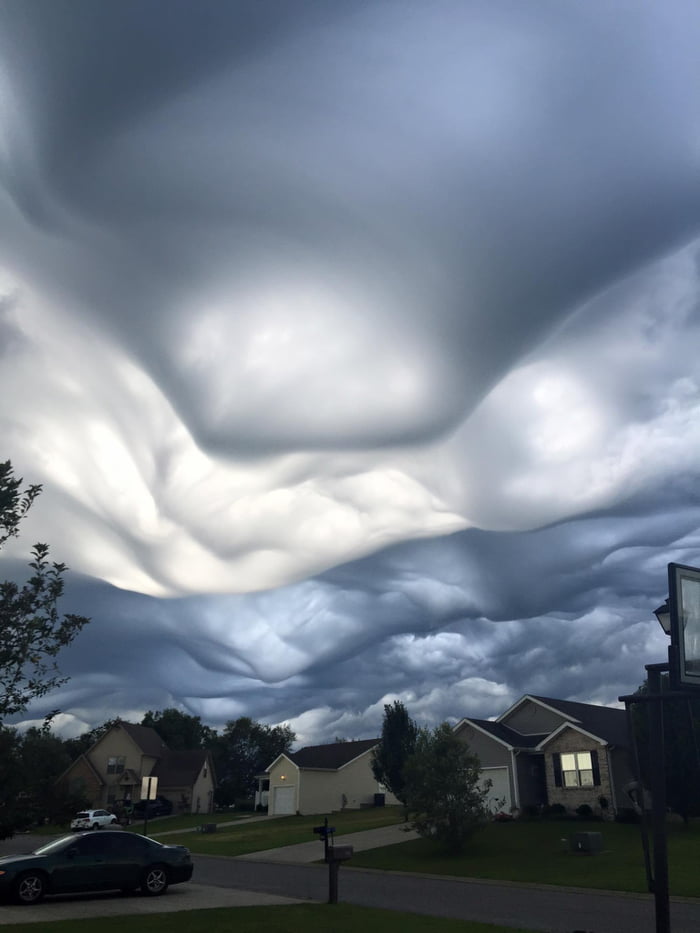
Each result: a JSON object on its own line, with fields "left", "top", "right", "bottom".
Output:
{"left": 404, "top": 722, "right": 489, "bottom": 853}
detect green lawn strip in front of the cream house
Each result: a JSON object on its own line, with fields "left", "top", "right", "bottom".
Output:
{"left": 156, "top": 807, "right": 403, "bottom": 858}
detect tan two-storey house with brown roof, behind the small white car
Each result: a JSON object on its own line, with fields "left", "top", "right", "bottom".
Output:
{"left": 59, "top": 722, "right": 215, "bottom": 813}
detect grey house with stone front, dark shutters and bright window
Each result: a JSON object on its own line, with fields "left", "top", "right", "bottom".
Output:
{"left": 454, "top": 695, "right": 634, "bottom": 814}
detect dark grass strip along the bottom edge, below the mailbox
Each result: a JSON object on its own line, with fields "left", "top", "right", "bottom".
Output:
{"left": 2, "top": 904, "right": 528, "bottom": 933}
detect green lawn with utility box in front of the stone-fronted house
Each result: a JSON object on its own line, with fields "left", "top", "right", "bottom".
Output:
{"left": 350, "top": 821, "right": 700, "bottom": 897}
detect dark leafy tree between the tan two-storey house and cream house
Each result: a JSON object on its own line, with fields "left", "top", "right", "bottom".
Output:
{"left": 211, "top": 716, "right": 296, "bottom": 806}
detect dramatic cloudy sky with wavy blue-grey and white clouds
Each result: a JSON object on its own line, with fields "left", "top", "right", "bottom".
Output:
{"left": 0, "top": 0, "right": 700, "bottom": 745}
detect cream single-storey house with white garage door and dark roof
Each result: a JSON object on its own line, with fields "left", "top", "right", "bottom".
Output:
{"left": 260, "top": 739, "right": 398, "bottom": 816}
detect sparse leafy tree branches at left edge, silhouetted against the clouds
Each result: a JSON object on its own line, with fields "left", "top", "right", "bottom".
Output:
{"left": 0, "top": 460, "right": 89, "bottom": 720}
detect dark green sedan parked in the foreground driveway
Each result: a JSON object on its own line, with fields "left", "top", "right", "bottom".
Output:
{"left": 0, "top": 830, "right": 192, "bottom": 904}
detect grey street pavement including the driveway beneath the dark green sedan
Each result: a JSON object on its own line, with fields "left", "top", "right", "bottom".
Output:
{"left": 0, "top": 836, "right": 700, "bottom": 933}
